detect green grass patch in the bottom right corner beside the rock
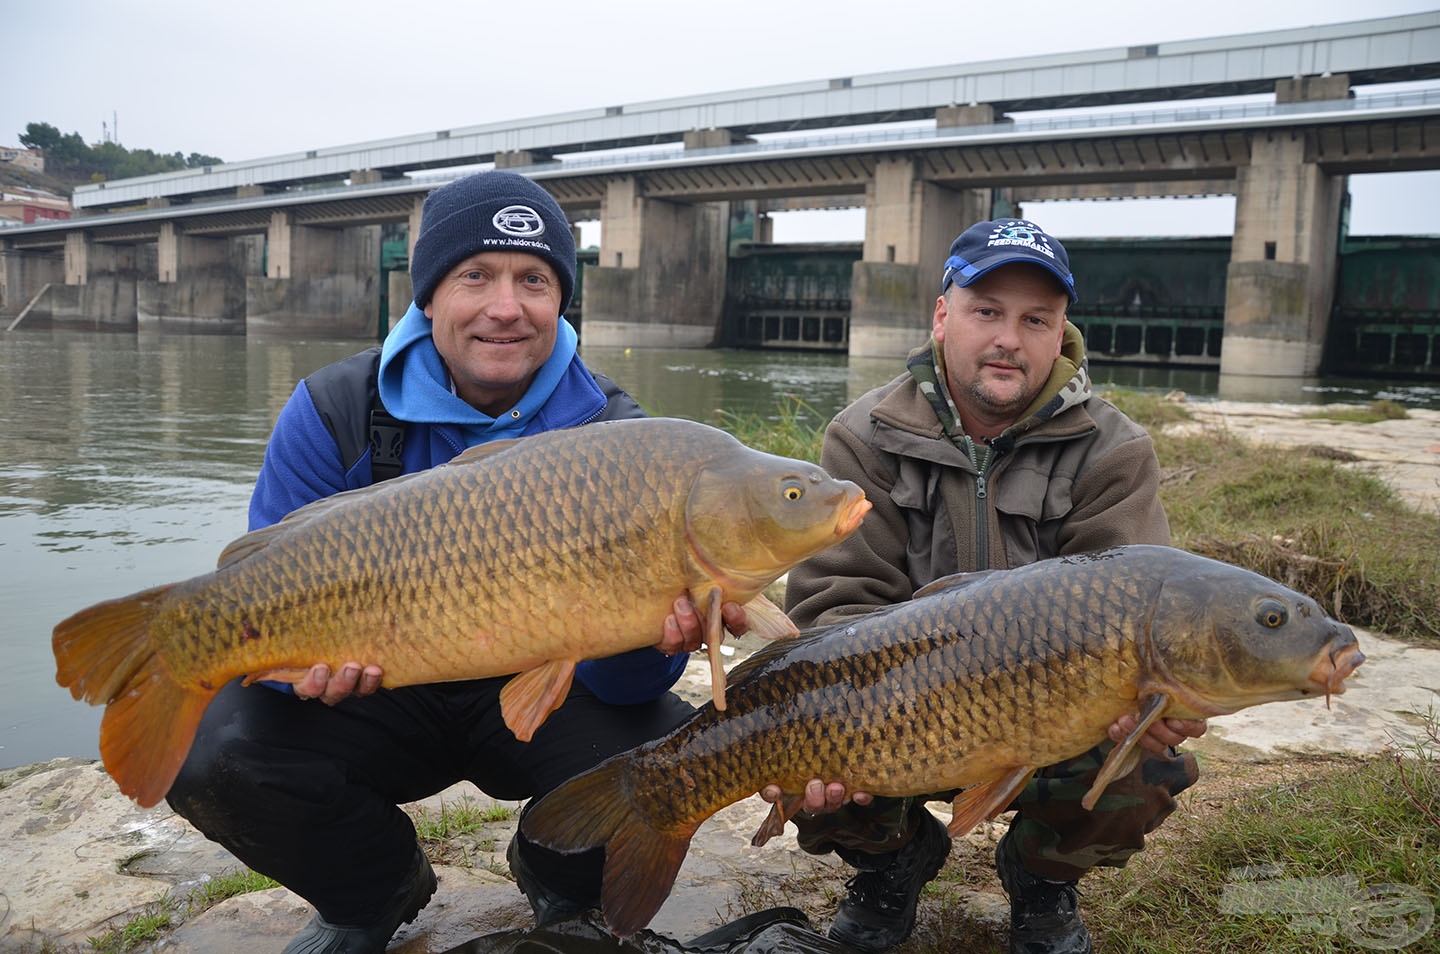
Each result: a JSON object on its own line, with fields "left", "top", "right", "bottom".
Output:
{"left": 1084, "top": 726, "right": 1440, "bottom": 954}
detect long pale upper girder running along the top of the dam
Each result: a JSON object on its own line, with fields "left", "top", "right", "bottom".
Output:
{"left": 75, "top": 12, "right": 1440, "bottom": 208}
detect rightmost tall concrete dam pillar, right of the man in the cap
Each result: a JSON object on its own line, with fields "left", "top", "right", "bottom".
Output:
{"left": 1220, "top": 131, "right": 1345, "bottom": 378}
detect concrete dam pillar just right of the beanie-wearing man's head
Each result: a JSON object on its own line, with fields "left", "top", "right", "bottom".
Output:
{"left": 582, "top": 176, "right": 730, "bottom": 347}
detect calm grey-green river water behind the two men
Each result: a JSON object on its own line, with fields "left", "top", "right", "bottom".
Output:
{"left": 0, "top": 330, "right": 1440, "bottom": 768}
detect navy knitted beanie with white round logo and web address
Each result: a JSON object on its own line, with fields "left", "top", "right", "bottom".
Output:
{"left": 410, "top": 171, "right": 575, "bottom": 314}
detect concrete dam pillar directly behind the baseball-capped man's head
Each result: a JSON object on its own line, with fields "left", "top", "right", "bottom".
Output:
{"left": 850, "top": 159, "right": 991, "bottom": 357}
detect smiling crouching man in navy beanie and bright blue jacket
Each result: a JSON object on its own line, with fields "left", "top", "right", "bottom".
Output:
{"left": 167, "top": 171, "right": 743, "bottom": 954}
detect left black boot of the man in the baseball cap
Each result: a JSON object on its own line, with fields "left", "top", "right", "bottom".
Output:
{"left": 829, "top": 811, "right": 950, "bottom": 954}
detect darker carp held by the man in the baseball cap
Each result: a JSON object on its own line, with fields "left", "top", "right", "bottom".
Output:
{"left": 521, "top": 546, "right": 1364, "bottom": 937}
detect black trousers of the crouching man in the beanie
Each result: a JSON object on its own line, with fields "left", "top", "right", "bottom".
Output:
{"left": 167, "top": 679, "right": 693, "bottom": 924}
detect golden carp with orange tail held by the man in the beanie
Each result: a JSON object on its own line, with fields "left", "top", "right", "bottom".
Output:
{"left": 53, "top": 418, "right": 870, "bottom": 806}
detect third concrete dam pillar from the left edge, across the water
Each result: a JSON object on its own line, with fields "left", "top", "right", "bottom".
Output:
{"left": 135, "top": 222, "right": 245, "bottom": 334}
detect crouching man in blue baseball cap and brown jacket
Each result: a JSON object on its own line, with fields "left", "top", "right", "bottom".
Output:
{"left": 783, "top": 219, "right": 1205, "bottom": 954}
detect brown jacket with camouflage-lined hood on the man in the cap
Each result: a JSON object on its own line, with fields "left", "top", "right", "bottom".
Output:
{"left": 786, "top": 326, "right": 1171, "bottom": 628}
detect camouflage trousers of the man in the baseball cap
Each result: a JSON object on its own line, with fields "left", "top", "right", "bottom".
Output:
{"left": 793, "top": 742, "right": 1200, "bottom": 881}
